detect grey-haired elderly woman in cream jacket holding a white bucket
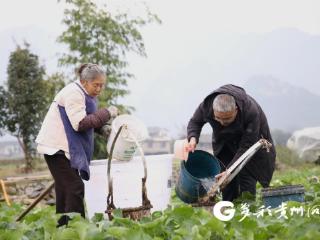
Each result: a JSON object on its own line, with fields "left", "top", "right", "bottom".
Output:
{"left": 36, "top": 63, "right": 117, "bottom": 226}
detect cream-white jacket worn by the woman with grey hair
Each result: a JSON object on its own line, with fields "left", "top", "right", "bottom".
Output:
{"left": 36, "top": 81, "right": 86, "bottom": 158}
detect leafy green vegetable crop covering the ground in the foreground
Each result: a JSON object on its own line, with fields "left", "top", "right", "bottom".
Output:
{"left": 0, "top": 164, "right": 320, "bottom": 240}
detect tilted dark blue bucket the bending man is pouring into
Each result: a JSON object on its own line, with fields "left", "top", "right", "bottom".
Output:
{"left": 175, "top": 150, "right": 220, "bottom": 203}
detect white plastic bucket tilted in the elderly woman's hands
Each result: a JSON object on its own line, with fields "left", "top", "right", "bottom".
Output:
{"left": 107, "top": 114, "right": 148, "bottom": 161}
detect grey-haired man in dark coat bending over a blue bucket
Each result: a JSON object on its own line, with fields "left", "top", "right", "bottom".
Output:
{"left": 188, "top": 84, "right": 276, "bottom": 201}
